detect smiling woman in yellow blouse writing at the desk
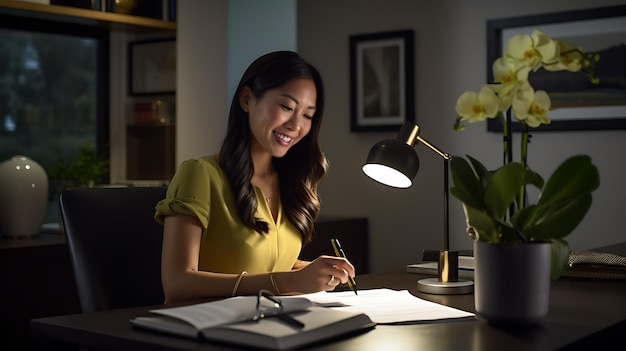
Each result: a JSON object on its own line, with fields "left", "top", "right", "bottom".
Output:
{"left": 155, "top": 51, "right": 355, "bottom": 302}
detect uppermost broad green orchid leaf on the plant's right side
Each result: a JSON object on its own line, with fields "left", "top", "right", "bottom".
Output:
{"left": 538, "top": 155, "right": 600, "bottom": 205}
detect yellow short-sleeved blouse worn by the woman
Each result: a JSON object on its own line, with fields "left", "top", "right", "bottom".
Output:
{"left": 155, "top": 156, "right": 302, "bottom": 274}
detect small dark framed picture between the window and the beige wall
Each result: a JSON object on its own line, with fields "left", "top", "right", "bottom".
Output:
{"left": 128, "top": 39, "right": 176, "bottom": 95}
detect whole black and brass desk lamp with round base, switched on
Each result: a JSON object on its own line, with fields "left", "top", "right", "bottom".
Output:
{"left": 363, "top": 122, "right": 474, "bottom": 295}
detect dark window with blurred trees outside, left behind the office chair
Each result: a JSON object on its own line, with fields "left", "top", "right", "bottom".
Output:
{"left": 0, "top": 16, "right": 109, "bottom": 221}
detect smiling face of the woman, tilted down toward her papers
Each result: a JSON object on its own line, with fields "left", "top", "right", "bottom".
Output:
{"left": 239, "top": 79, "right": 317, "bottom": 157}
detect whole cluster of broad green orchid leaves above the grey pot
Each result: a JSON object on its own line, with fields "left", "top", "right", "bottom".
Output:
{"left": 450, "top": 156, "right": 600, "bottom": 248}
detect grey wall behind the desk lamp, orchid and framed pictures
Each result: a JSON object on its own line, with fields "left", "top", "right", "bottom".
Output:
{"left": 298, "top": 0, "right": 626, "bottom": 271}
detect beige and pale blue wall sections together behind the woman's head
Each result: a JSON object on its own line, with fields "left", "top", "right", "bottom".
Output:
{"left": 176, "top": 0, "right": 296, "bottom": 163}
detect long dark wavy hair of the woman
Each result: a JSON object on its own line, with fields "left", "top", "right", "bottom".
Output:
{"left": 219, "top": 51, "right": 328, "bottom": 243}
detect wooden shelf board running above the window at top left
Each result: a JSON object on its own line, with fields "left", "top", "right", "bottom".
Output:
{"left": 0, "top": 0, "right": 176, "bottom": 32}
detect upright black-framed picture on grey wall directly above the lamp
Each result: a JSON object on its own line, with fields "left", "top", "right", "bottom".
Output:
{"left": 350, "top": 30, "right": 415, "bottom": 132}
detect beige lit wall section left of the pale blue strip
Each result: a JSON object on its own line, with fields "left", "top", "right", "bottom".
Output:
{"left": 176, "top": 0, "right": 228, "bottom": 163}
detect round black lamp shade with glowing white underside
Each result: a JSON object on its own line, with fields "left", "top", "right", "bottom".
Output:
{"left": 363, "top": 139, "right": 419, "bottom": 188}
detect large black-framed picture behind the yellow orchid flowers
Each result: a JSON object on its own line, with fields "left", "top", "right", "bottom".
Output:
{"left": 487, "top": 6, "right": 626, "bottom": 132}
